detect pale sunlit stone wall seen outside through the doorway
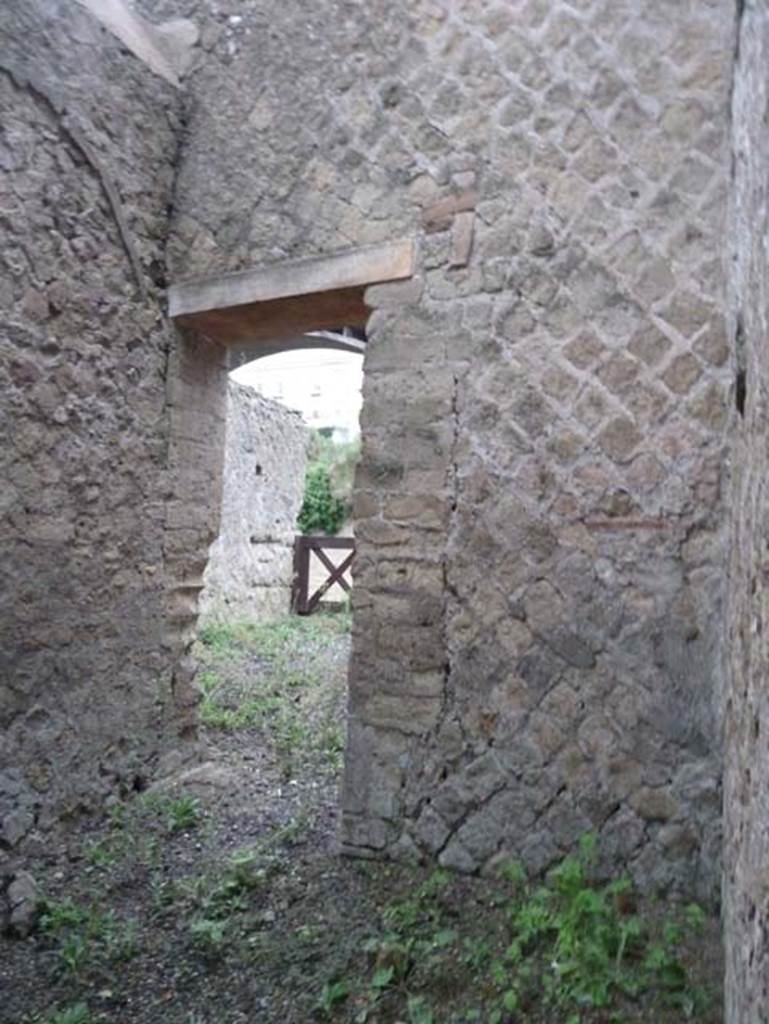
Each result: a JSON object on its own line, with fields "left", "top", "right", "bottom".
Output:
{"left": 200, "top": 381, "right": 309, "bottom": 623}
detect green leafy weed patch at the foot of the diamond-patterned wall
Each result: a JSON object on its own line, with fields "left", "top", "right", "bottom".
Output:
{"left": 329, "top": 835, "right": 708, "bottom": 1024}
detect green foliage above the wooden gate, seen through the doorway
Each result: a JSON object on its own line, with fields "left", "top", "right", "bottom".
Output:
{"left": 297, "top": 431, "right": 360, "bottom": 534}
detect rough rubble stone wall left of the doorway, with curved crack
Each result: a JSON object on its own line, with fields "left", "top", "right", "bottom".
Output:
{"left": 0, "top": 0, "right": 185, "bottom": 859}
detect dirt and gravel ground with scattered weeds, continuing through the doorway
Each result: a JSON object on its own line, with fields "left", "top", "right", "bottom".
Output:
{"left": 0, "top": 614, "right": 722, "bottom": 1024}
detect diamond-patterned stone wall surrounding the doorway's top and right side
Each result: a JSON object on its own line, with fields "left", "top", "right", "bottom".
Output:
{"left": 163, "top": 0, "right": 733, "bottom": 897}
